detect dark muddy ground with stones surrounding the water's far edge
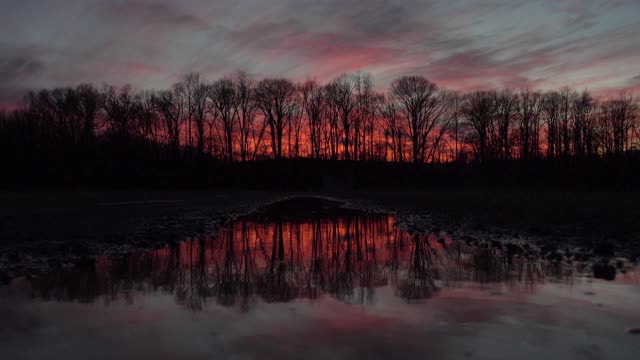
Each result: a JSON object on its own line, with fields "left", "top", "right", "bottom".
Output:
{"left": 0, "top": 189, "right": 640, "bottom": 282}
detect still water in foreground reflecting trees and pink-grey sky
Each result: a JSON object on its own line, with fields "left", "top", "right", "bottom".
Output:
{"left": 0, "top": 201, "right": 640, "bottom": 359}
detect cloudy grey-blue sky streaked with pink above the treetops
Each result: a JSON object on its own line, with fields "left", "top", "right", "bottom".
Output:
{"left": 0, "top": 0, "right": 640, "bottom": 107}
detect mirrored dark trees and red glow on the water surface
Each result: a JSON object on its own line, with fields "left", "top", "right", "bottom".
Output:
{"left": 21, "top": 214, "right": 584, "bottom": 310}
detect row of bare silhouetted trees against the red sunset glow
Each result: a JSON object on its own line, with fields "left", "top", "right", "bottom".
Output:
{"left": 0, "top": 72, "right": 640, "bottom": 163}
